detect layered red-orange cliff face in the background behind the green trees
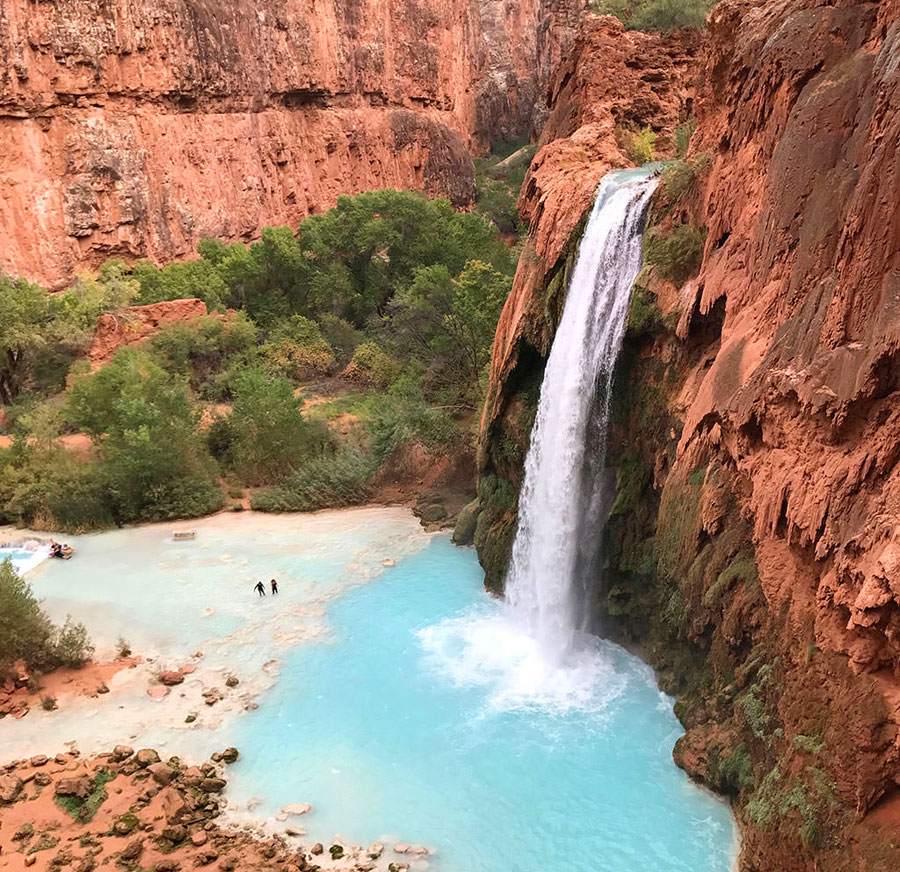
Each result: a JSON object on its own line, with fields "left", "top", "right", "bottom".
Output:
{"left": 0, "top": 0, "right": 581, "bottom": 284}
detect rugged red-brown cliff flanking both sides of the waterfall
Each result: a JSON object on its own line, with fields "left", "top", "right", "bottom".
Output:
{"left": 478, "top": 0, "right": 900, "bottom": 872}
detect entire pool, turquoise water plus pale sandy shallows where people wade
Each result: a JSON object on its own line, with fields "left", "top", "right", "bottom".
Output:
{"left": 0, "top": 509, "right": 735, "bottom": 872}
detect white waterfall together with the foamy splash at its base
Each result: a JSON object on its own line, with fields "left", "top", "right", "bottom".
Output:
{"left": 419, "top": 169, "right": 656, "bottom": 717}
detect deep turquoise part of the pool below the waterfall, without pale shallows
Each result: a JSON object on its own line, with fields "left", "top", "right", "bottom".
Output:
{"left": 223, "top": 537, "right": 733, "bottom": 872}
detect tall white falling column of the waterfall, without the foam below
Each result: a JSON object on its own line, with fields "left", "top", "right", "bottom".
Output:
{"left": 506, "top": 170, "right": 656, "bottom": 659}
